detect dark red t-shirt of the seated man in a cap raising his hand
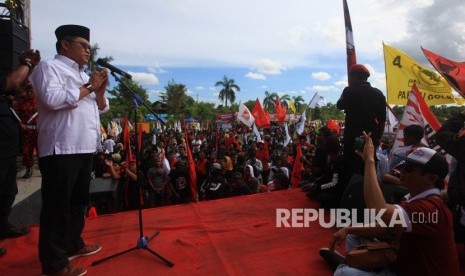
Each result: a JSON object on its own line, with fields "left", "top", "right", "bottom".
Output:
{"left": 394, "top": 196, "right": 459, "bottom": 276}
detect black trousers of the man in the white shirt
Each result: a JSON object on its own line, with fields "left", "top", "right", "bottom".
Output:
{"left": 39, "top": 154, "right": 93, "bottom": 273}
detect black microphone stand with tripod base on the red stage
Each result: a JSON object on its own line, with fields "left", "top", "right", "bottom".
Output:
{"left": 92, "top": 72, "right": 174, "bottom": 267}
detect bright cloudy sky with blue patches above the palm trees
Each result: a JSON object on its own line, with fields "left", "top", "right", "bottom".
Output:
{"left": 31, "top": 0, "right": 465, "bottom": 104}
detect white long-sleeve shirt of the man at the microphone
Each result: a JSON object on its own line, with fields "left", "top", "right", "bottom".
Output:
{"left": 29, "top": 55, "right": 109, "bottom": 157}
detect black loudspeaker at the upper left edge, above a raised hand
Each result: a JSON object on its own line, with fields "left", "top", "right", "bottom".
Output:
{"left": 0, "top": 19, "right": 31, "bottom": 75}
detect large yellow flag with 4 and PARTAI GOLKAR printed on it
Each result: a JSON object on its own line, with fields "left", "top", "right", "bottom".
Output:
{"left": 383, "top": 44, "right": 455, "bottom": 105}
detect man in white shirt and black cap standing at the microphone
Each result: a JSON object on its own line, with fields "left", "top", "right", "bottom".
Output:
{"left": 29, "top": 25, "right": 109, "bottom": 275}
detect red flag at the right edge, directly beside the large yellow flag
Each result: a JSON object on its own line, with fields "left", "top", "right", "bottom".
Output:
{"left": 421, "top": 47, "right": 465, "bottom": 97}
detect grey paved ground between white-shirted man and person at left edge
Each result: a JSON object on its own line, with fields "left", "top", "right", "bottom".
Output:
{"left": 9, "top": 159, "right": 42, "bottom": 225}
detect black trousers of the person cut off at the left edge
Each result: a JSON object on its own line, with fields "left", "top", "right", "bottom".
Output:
{"left": 0, "top": 157, "right": 18, "bottom": 231}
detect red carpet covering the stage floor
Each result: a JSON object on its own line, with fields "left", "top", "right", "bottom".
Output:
{"left": 0, "top": 189, "right": 464, "bottom": 276}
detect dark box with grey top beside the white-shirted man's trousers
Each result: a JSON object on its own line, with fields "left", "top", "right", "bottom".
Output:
{"left": 89, "top": 178, "right": 121, "bottom": 214}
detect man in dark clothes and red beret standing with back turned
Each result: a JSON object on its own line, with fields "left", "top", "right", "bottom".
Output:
{"left": 337, "top": 64, "right": 386, "bottom": 174}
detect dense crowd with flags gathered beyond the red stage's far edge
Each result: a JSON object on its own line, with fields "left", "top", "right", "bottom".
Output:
{"left": 94, "top": 122, "right": 315, "bottom": 210}
